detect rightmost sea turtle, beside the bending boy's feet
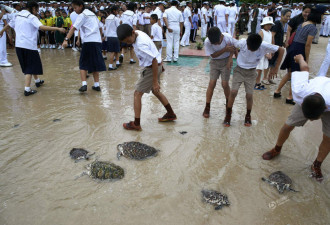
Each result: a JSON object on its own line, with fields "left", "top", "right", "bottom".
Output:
{"left": 261, "top": 171, "right": 298, "bottom": 194}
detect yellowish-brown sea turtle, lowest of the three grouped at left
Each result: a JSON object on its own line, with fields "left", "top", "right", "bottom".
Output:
{"left": 77, "top": 160, "right": 125, "bottom": 180}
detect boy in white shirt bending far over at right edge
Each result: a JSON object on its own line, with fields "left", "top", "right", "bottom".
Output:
{"left": 262, "top": 55, "right": 330, "bottom": 181}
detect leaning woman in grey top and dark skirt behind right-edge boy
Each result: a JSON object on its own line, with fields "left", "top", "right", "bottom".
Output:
{"left": 274, "top": 6, "right": 325, "bottom": 105}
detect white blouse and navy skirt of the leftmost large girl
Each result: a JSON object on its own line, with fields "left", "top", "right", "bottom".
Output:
{"left": 9, "top": 10, "right": 43, "bottom": 75}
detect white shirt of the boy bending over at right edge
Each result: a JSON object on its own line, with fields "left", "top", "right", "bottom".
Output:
{"left": 291, "top": 71, "right": 330, "bottom": 111}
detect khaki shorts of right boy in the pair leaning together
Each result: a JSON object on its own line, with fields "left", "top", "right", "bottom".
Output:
{"left": 231, "top": 66, "right": 257, "bottom": 94}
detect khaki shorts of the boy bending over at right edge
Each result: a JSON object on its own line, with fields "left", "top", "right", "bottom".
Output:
{"left": 285, "top": 104, "right": 330, "bottom": 137}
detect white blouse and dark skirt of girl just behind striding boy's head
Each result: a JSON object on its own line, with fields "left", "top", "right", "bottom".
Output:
{"left": 105, "top": 14, "right": 120, "bottom": 52}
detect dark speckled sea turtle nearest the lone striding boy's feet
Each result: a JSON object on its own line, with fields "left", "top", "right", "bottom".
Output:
{"left": 117, "top": 141, "right": 158, "bottom": 160}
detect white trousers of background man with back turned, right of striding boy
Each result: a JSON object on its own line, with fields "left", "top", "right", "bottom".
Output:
{"left": 166, "top": 28, "right": 180, "bottom": 60}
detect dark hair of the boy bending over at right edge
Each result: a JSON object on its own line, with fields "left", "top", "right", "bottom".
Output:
{"left": 301, "top": 94, "right": 326, "bottom": 120}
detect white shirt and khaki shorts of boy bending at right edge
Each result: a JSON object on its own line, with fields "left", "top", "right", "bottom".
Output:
{"left": 286, "top": 71, "right": 330, "bottom": 137}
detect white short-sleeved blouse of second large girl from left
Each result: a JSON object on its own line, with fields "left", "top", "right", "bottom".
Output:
{"left": 73, "top": 9, "right": 102, "bottom": 43}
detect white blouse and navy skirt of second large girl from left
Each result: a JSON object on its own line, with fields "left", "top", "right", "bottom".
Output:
{"left": 73, "top": 9, "right": 106, "bottom": 73}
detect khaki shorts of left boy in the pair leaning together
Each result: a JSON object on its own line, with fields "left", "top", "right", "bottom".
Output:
{"left": 210, "top": 58, "right": 230, "bottom": 81}
